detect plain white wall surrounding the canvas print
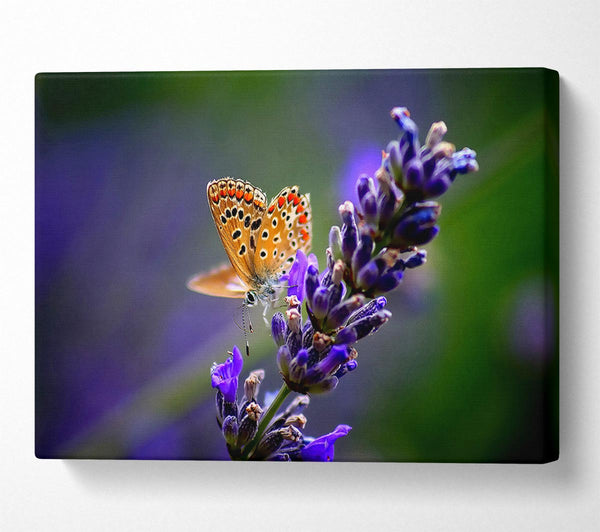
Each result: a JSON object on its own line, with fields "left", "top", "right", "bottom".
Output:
{"left": 0, "top": 0, "right": 600, "bottom": 531}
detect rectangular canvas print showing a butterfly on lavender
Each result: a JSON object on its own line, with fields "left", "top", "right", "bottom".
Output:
{"left": 35, "top": 68, "right": 558, "bottom": 463}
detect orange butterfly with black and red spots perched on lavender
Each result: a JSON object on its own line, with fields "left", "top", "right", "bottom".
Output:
{"left": 188, "top": 177, "right": 312, "bottom": 310}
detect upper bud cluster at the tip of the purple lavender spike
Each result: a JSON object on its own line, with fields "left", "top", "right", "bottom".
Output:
{"left": 329, "top": 107, "right": 478, "bottom": 297}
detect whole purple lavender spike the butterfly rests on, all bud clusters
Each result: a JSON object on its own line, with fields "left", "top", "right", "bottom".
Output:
{"left": 206, "top": 107, "right": 478, "bottom": 461}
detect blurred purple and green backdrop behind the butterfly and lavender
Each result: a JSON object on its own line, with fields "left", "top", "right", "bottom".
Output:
{"left": 36, "top": 69, "right": 558, "bottom": 462}
